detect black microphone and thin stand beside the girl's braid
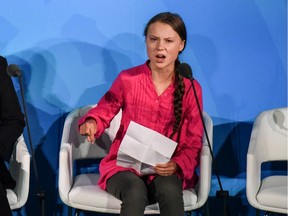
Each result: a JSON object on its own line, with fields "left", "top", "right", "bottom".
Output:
{"left": 178, "top": 63, "right": 229, "bottom": 215}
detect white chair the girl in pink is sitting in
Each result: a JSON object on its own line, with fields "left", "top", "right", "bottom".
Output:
{"left": 58, "top": 106, "right": 213, "bottom": 214}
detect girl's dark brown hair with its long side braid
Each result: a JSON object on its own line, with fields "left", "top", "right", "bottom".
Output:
{"left": 144, "top": 12, "right": 187, "bottom": 139}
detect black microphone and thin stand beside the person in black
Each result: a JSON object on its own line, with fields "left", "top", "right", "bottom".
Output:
{"left": 6, "top": 64, "right": 45, "bottom": 216}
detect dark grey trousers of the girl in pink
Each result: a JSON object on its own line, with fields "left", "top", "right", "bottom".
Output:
{"left": 107, "top": 171, "right": 184, "bottom": 216}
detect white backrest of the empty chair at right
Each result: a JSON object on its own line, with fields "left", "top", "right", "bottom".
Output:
{"left": 249, "top": 108, "right": 288, "bottom": 162}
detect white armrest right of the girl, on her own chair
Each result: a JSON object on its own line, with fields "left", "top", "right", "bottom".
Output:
{"left": 196, "top": 145, "right": 212, "bottom": 208}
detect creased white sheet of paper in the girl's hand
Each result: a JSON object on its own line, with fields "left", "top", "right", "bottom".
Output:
{"left": 117, "top": 121, "right": 177, "bottom": 175}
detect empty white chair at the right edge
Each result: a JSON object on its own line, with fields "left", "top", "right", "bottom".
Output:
{"left": 246, "top": 108, "right": 288, "bottom": 214}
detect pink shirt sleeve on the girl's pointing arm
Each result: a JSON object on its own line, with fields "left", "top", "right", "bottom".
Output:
{"left": 78, "top": 73, "right": 124, "bottom": 138}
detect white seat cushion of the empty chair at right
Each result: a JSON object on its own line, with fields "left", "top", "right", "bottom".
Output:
{"left": 256, "top": 176, "right": 288, "bottom": 209}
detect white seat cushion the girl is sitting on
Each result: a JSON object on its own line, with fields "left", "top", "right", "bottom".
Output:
{"left": 69, "top": 174, "right": 197, "bottom": 214}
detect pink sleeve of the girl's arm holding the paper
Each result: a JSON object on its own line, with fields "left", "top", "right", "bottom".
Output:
{"left": 172, "top": 80, "right": 203, "bottom": 183}
